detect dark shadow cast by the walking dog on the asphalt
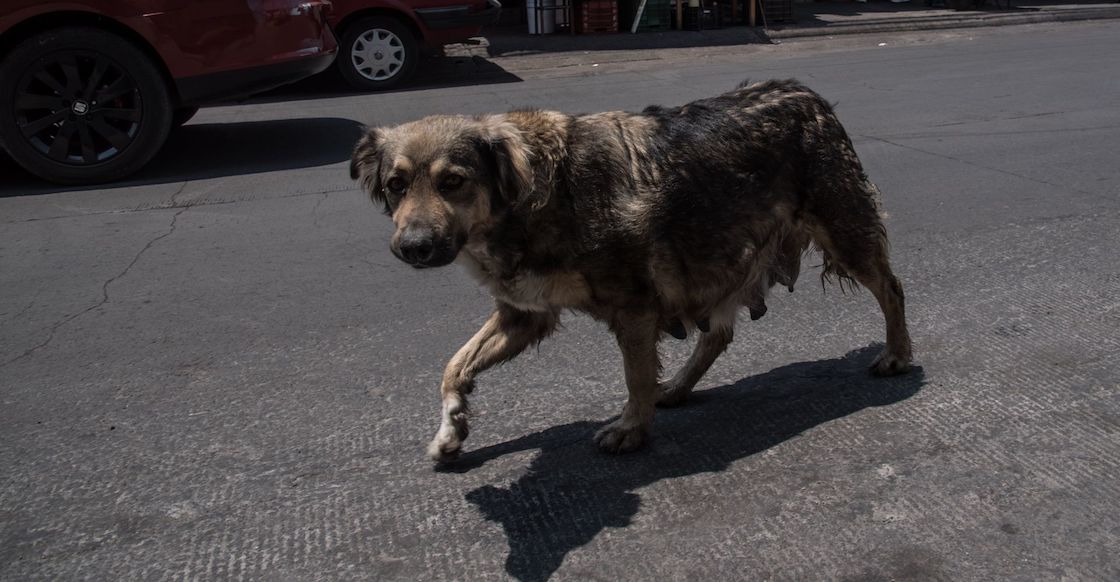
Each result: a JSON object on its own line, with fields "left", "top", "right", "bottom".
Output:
{"left": 441, "top": 346, "right": 925, "bottom": 581}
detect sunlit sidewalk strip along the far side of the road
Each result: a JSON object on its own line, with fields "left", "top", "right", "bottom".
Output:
{"left": 446, "top": 0, "right": 1120, "bottom": 57}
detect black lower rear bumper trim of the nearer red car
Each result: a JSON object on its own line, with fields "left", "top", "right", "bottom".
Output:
{"left": 176, "top": 50, "right": 335, "bottom": 105}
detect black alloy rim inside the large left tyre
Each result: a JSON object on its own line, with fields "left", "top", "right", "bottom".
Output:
{"left": 15, "top": 50, "right": 143, "bottom": 166}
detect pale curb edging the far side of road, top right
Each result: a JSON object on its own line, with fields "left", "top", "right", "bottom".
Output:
{"left": 766, "top": 6, "right": 1120, "bottom": 40}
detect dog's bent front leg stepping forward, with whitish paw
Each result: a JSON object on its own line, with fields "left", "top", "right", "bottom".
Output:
{"left": 428, "top": 302, "right": 558, "bottom": 461}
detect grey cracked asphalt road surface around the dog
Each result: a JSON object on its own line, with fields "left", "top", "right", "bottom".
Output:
{"left": 0, "top": 18, "right": 1120, "bottom": 581}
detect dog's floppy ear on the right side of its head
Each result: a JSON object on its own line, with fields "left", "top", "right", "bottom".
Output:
{"left": 483, "top": 115, "right": 548, "bottom": 210}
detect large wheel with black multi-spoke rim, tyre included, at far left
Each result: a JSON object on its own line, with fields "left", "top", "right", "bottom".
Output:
{"left": 0, "top": 27, "right": 171, "bottom": 184}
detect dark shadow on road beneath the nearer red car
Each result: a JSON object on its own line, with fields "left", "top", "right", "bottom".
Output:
{"left": 0, "top": 118, "right": 362, "bottom": 197}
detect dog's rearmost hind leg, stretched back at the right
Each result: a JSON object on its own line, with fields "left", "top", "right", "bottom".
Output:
{"left": 810, "top": 181, "right": 913, "bottom": 376}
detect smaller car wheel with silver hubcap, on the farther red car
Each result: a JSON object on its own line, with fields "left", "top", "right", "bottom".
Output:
{"left": 336, "top": 17, "right": 420, "bottom": 91}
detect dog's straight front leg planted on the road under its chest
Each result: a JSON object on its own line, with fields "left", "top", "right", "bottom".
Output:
{"left": 595, "top": 312, "right": 661, "bottom": 452}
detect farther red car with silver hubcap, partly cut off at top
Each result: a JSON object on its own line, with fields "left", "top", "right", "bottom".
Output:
{"left": 330, "top": 0, "right": 502, "bottom": 91}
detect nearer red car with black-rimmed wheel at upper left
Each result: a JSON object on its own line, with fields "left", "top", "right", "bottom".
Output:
{"left": 0, "top": 0, "right": 337, "bottom": 184}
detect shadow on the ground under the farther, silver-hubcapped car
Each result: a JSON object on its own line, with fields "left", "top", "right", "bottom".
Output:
{"left": 246, "top": 55, "right": 521, "bottom": 103}
